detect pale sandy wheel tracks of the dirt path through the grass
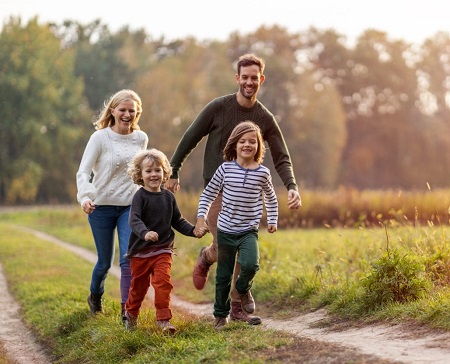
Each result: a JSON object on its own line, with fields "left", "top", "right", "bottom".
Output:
{"left": 0, "top": 227, "right": 450, "bottom": 364}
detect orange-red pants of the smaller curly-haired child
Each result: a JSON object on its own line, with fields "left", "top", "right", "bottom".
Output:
{"left": 125, "top": 253, "right": 173, "bottom": 321}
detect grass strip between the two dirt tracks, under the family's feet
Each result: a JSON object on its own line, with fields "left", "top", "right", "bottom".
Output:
{"left": 0, "top": 222, "right": 293, "bottom": 364}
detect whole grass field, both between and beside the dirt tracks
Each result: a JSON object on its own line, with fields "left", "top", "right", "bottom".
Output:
{"left": 0, "top": 206, "right": 450, "bottom": 363}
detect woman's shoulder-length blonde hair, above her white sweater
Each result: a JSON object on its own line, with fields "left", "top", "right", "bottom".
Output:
{"left": 94, "top": 89, "right": 142, "bottom": 130}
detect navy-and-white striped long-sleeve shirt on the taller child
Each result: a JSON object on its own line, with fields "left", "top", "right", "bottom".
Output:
{"left": 197, "top": 161, "right": 278, "bottom": 234}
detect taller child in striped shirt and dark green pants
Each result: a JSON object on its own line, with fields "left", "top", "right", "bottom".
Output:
{"left": 196, "top": 121, "right": 278, "bottom": 330}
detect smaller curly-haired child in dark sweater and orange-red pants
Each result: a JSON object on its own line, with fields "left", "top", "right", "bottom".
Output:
{"left": 125, "top": 149, "right": 207, "bottom": 333}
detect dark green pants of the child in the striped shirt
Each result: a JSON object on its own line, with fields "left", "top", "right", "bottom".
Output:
{"left": 214, "top": 230, "right": 259, "bottom": 317}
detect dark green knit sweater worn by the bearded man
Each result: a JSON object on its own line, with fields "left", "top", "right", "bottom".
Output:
{"left": 170, "top": 94, "right": 297, "bottom": 190}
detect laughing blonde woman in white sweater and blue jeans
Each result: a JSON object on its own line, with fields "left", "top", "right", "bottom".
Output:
{"left": 77, "top": 90, "right": 148, "bottom": 320}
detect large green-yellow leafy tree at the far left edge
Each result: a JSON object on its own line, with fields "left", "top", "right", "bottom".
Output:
{"left": 0, "top": 18, "right": 88, "bottom": 203}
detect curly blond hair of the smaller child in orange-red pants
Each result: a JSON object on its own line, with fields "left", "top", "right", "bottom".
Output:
{"left": 128, "top": 148, "right": 172, "bottom": 186}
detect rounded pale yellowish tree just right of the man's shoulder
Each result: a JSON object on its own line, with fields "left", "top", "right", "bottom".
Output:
{"left": 289, "top": 72, "right": 347, "bottom": 189}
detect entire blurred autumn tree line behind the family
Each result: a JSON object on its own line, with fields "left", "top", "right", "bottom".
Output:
{"left": 0, "top": 17, "right": 450, "bottom": 204}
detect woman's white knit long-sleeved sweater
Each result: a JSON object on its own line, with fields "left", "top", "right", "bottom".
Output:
{"left": 77, "top": 128, "right": 148, "bottom": 206}
